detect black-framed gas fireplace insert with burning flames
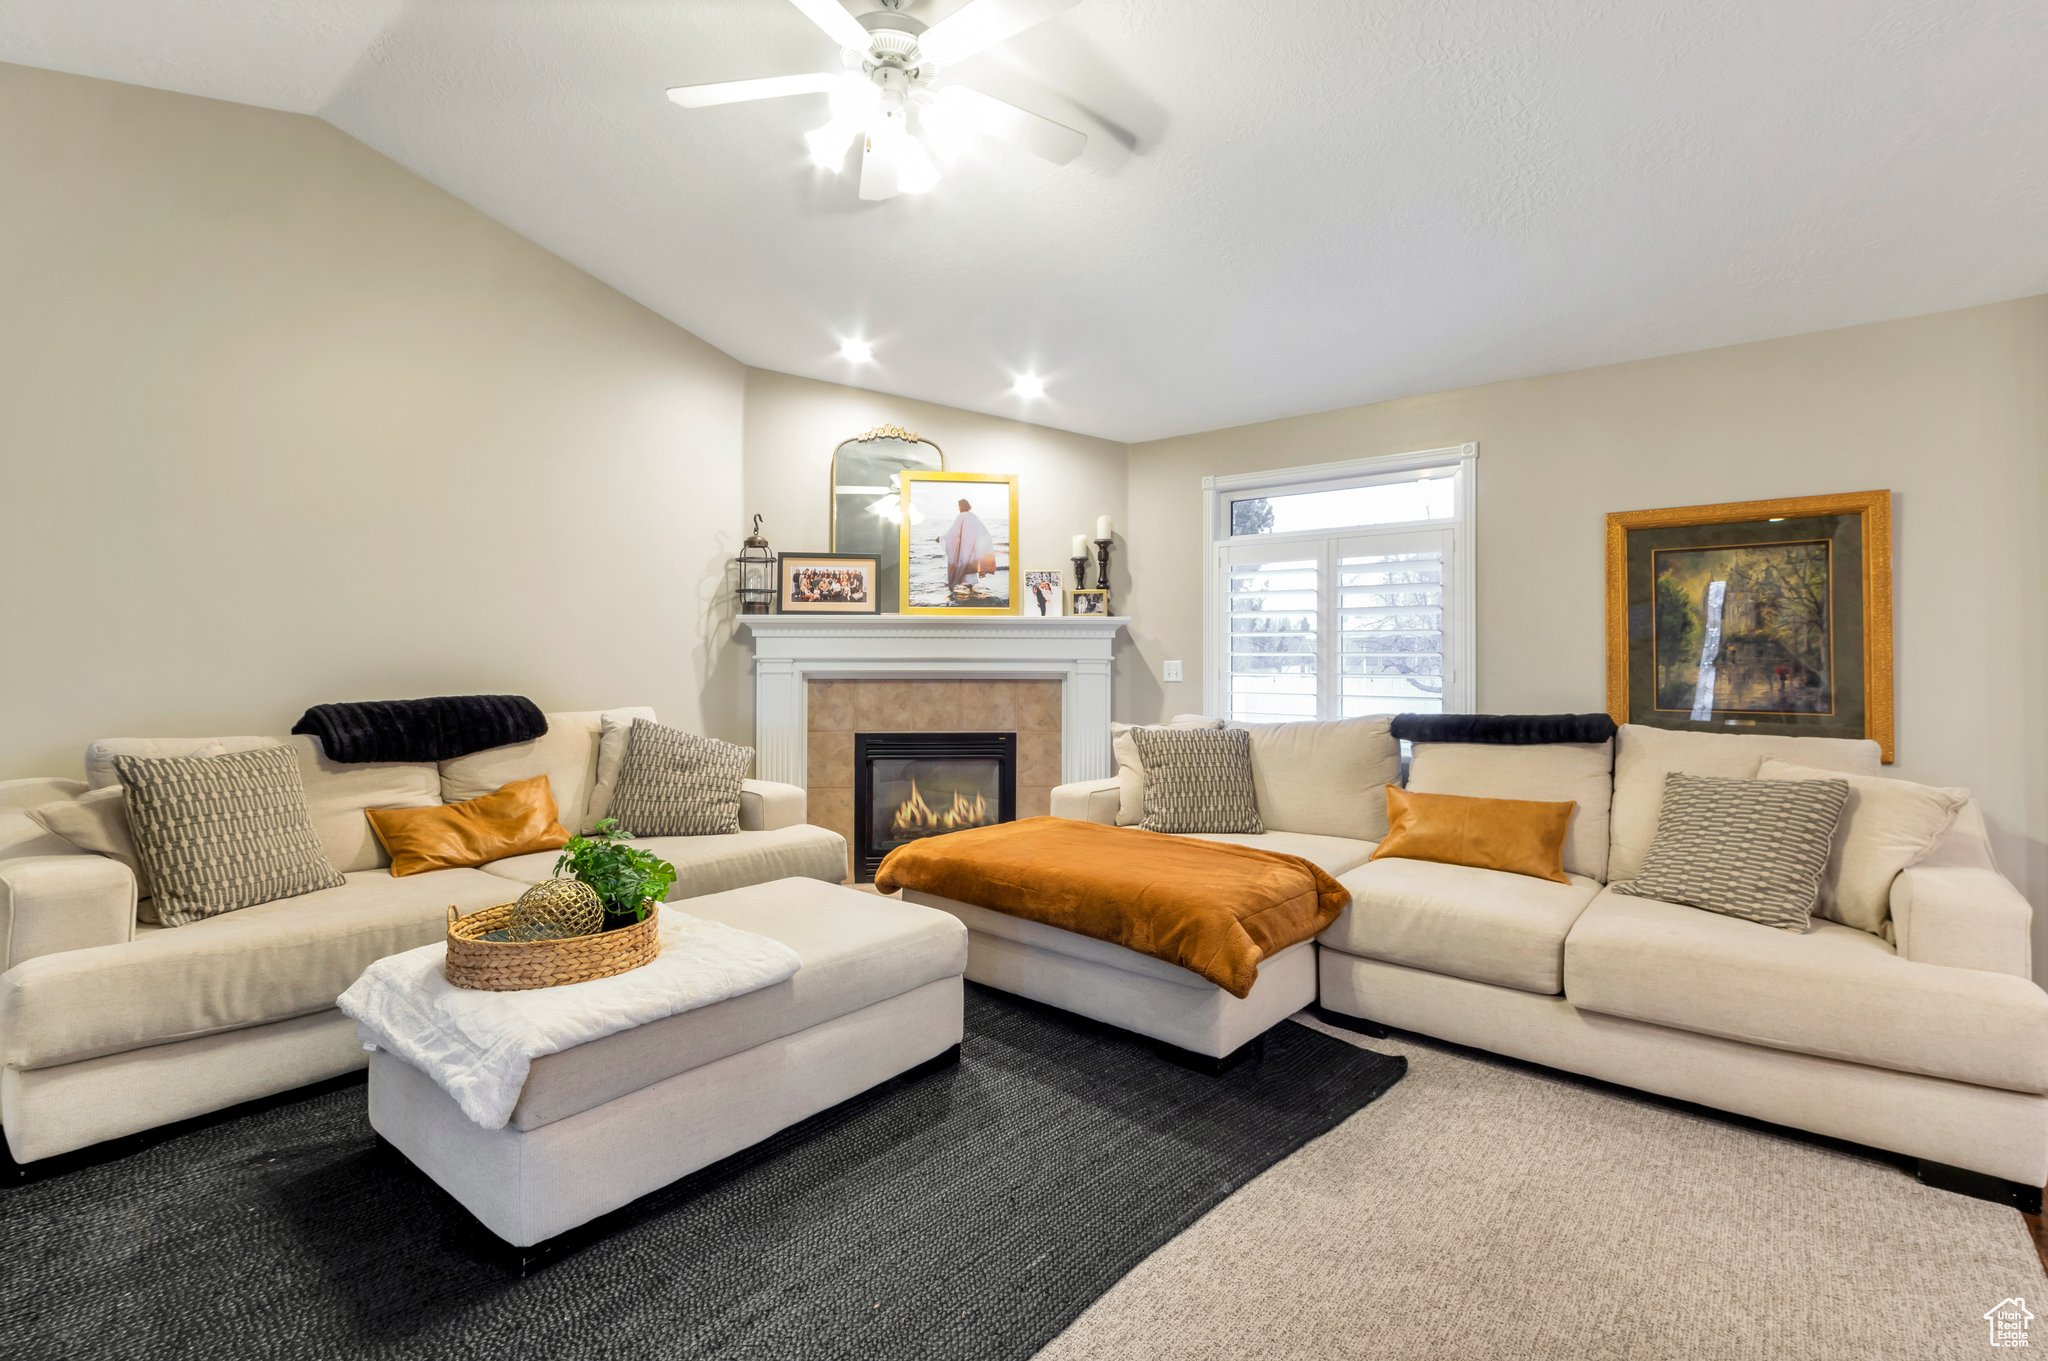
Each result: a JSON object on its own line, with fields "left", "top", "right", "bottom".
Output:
{"left": 854, "top": 733, "right": 1018, "bottom": 884}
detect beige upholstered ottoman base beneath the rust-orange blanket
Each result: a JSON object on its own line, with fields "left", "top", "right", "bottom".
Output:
{"left": 903, "top": 888, "right": 1315, "bottom": 1068}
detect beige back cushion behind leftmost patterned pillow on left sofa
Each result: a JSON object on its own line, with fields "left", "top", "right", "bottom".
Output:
{"left": 86, "top": 737, "right": 440, "bottom": 874}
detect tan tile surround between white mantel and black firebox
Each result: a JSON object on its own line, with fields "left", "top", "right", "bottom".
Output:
{"left": 805, "top": 679, "right": 1061, "bottom": 875}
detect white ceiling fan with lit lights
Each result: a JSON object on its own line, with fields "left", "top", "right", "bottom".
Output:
{"left": 668, "top": 0, "right": 1087, "bottom": 201}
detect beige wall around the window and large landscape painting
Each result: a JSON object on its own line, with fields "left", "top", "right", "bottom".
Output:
{"left": 1116, "top": 297, "right": 2048, "bottom": 933}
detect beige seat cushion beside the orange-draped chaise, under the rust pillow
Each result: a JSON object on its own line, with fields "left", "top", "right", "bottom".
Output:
{"left": 1317, "top": 860, "right": 1599, "bottom": 995}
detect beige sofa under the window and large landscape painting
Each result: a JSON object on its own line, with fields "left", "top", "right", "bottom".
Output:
{"left": 1053, "top": 720, "right": 2048, "bottom": 1201}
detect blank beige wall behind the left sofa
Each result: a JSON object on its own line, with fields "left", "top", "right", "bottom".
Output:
{"left": 0, "top": 65, "right": 748, "bottom": 778}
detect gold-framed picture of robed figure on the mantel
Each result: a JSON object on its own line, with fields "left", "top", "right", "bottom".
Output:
{"left": 897, "top": 471, "right": 1018, "bottom": 614}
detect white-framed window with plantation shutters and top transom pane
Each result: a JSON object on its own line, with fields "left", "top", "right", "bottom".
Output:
{"left": 1204, "top": 444, "right": 1479, "bottom": 722}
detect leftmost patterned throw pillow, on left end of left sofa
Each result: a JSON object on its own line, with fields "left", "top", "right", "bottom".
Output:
{"left": 115, "top": 747, "right": 346, "bottom": 927}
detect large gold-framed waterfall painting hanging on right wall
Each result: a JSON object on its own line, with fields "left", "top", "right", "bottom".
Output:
{"left": 1608, "top": 491, "right": 1892, "bottom": 763}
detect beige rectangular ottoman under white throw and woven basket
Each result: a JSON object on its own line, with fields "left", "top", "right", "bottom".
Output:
{"left": 369, "top": 878, "right": 967, "bottom": 1246}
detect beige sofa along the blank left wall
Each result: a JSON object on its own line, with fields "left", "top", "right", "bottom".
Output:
{"left": 0, "top": 708, "right": 846, "bottom": 1162}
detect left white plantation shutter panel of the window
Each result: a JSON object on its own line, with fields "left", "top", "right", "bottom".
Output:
{"left": 1225, "top": 544, "right": 1323, "bottom": 722}
